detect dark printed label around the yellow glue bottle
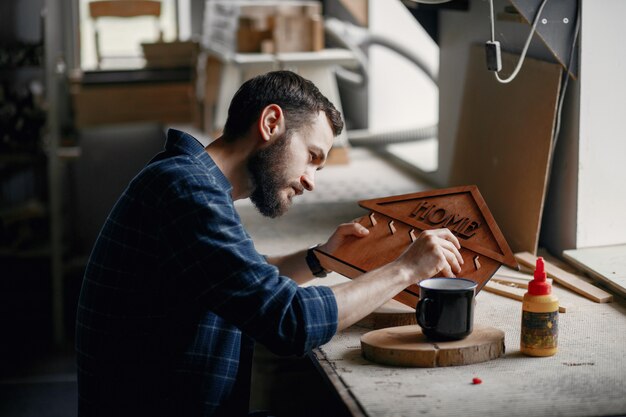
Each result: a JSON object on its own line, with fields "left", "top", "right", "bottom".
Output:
{"left": 521, "top": 311, "right": 559, "bottom": 349}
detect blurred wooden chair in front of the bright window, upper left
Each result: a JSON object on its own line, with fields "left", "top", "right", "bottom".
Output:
{"left": 89, "top": 0, "right": 163, "bottom": 68}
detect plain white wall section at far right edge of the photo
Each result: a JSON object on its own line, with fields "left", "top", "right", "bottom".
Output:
{"left": 576, "top": 0, "right": 626, "bottom": 247}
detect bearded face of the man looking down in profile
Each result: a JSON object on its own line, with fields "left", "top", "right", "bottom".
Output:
{"left": 248, "top": 112, "right": 334, "bottom": 217}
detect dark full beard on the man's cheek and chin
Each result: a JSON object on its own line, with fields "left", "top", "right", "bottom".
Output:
{"left": 248, "top": 134, "right": 291, "bottom": 218}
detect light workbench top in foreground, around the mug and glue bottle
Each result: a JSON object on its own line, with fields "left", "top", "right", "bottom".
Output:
{"left": 310, "top": 274, "right": 626, "bottom": 416}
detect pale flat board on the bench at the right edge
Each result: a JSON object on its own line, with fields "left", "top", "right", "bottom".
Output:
{"left": 563, "top": 245, "right": 626, "bottom": 297}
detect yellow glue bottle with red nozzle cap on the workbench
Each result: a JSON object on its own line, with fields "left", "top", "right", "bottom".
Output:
{"left": 520, "top": 257, "right": 559, "bottom": 356}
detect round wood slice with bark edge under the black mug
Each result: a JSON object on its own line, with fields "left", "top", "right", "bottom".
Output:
{"left": 361, "top": 325, "right": 504, "bottom": 368}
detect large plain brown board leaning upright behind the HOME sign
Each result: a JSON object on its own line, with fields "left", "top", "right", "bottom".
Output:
{"left": 450, "top": 45, "right": 561, "bottom": 253}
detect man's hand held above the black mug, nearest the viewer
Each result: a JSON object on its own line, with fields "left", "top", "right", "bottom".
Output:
{"left": 395, "top": 229, "right": 463, "bottom": 283}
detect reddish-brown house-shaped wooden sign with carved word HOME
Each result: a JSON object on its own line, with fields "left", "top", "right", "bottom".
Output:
{"left": 316, "top": 185, "right": 518, "bottom": 307}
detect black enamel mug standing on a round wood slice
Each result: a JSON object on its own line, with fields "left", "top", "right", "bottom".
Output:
{"left": 415, "top": 278, "right": 476, "bottom": 341}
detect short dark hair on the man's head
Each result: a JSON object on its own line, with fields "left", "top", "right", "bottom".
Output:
{"left": 224, "top": 71, "right": 343, "bottom": 140}
